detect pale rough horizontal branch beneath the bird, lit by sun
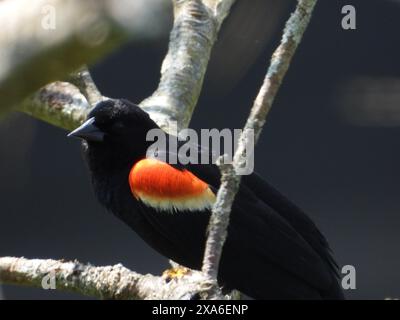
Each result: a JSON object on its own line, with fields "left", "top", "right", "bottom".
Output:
{"left": 0, "top": 257, "right": 222, "bottom": 300}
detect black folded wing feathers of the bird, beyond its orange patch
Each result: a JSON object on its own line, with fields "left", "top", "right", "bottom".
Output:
{"left": 188, "top": 165, "right": 333, "bottom": 289}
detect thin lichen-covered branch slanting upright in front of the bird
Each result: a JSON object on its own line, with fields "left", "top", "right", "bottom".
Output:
{"left": 202, "top": 0, "right": 317, "bottom": 279}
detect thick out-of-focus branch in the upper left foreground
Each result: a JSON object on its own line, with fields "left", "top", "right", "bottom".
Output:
{"left": 0, "top": 0, "right": 168, "bottom": 112}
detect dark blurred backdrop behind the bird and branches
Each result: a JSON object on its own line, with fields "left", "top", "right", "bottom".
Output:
{"left": 0, "top": 0, "right": 400, "bottom": 299}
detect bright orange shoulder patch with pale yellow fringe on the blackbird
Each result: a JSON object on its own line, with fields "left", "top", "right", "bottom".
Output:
{"left": 129, "top": 159, "right": 215, "bottom": 211}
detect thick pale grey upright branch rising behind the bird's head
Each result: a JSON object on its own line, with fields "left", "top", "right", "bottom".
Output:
{"left": 140, "top": 0, "right": 235, "bottom": 133}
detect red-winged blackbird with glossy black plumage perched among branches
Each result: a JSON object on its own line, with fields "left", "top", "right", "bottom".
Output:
{"left": 70, "top": 99, "right": 343, "bottom": 299}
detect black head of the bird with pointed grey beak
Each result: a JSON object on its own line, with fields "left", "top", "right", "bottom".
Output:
{"left": 68, "top": 99, "right": 159, "bottom": 171}
